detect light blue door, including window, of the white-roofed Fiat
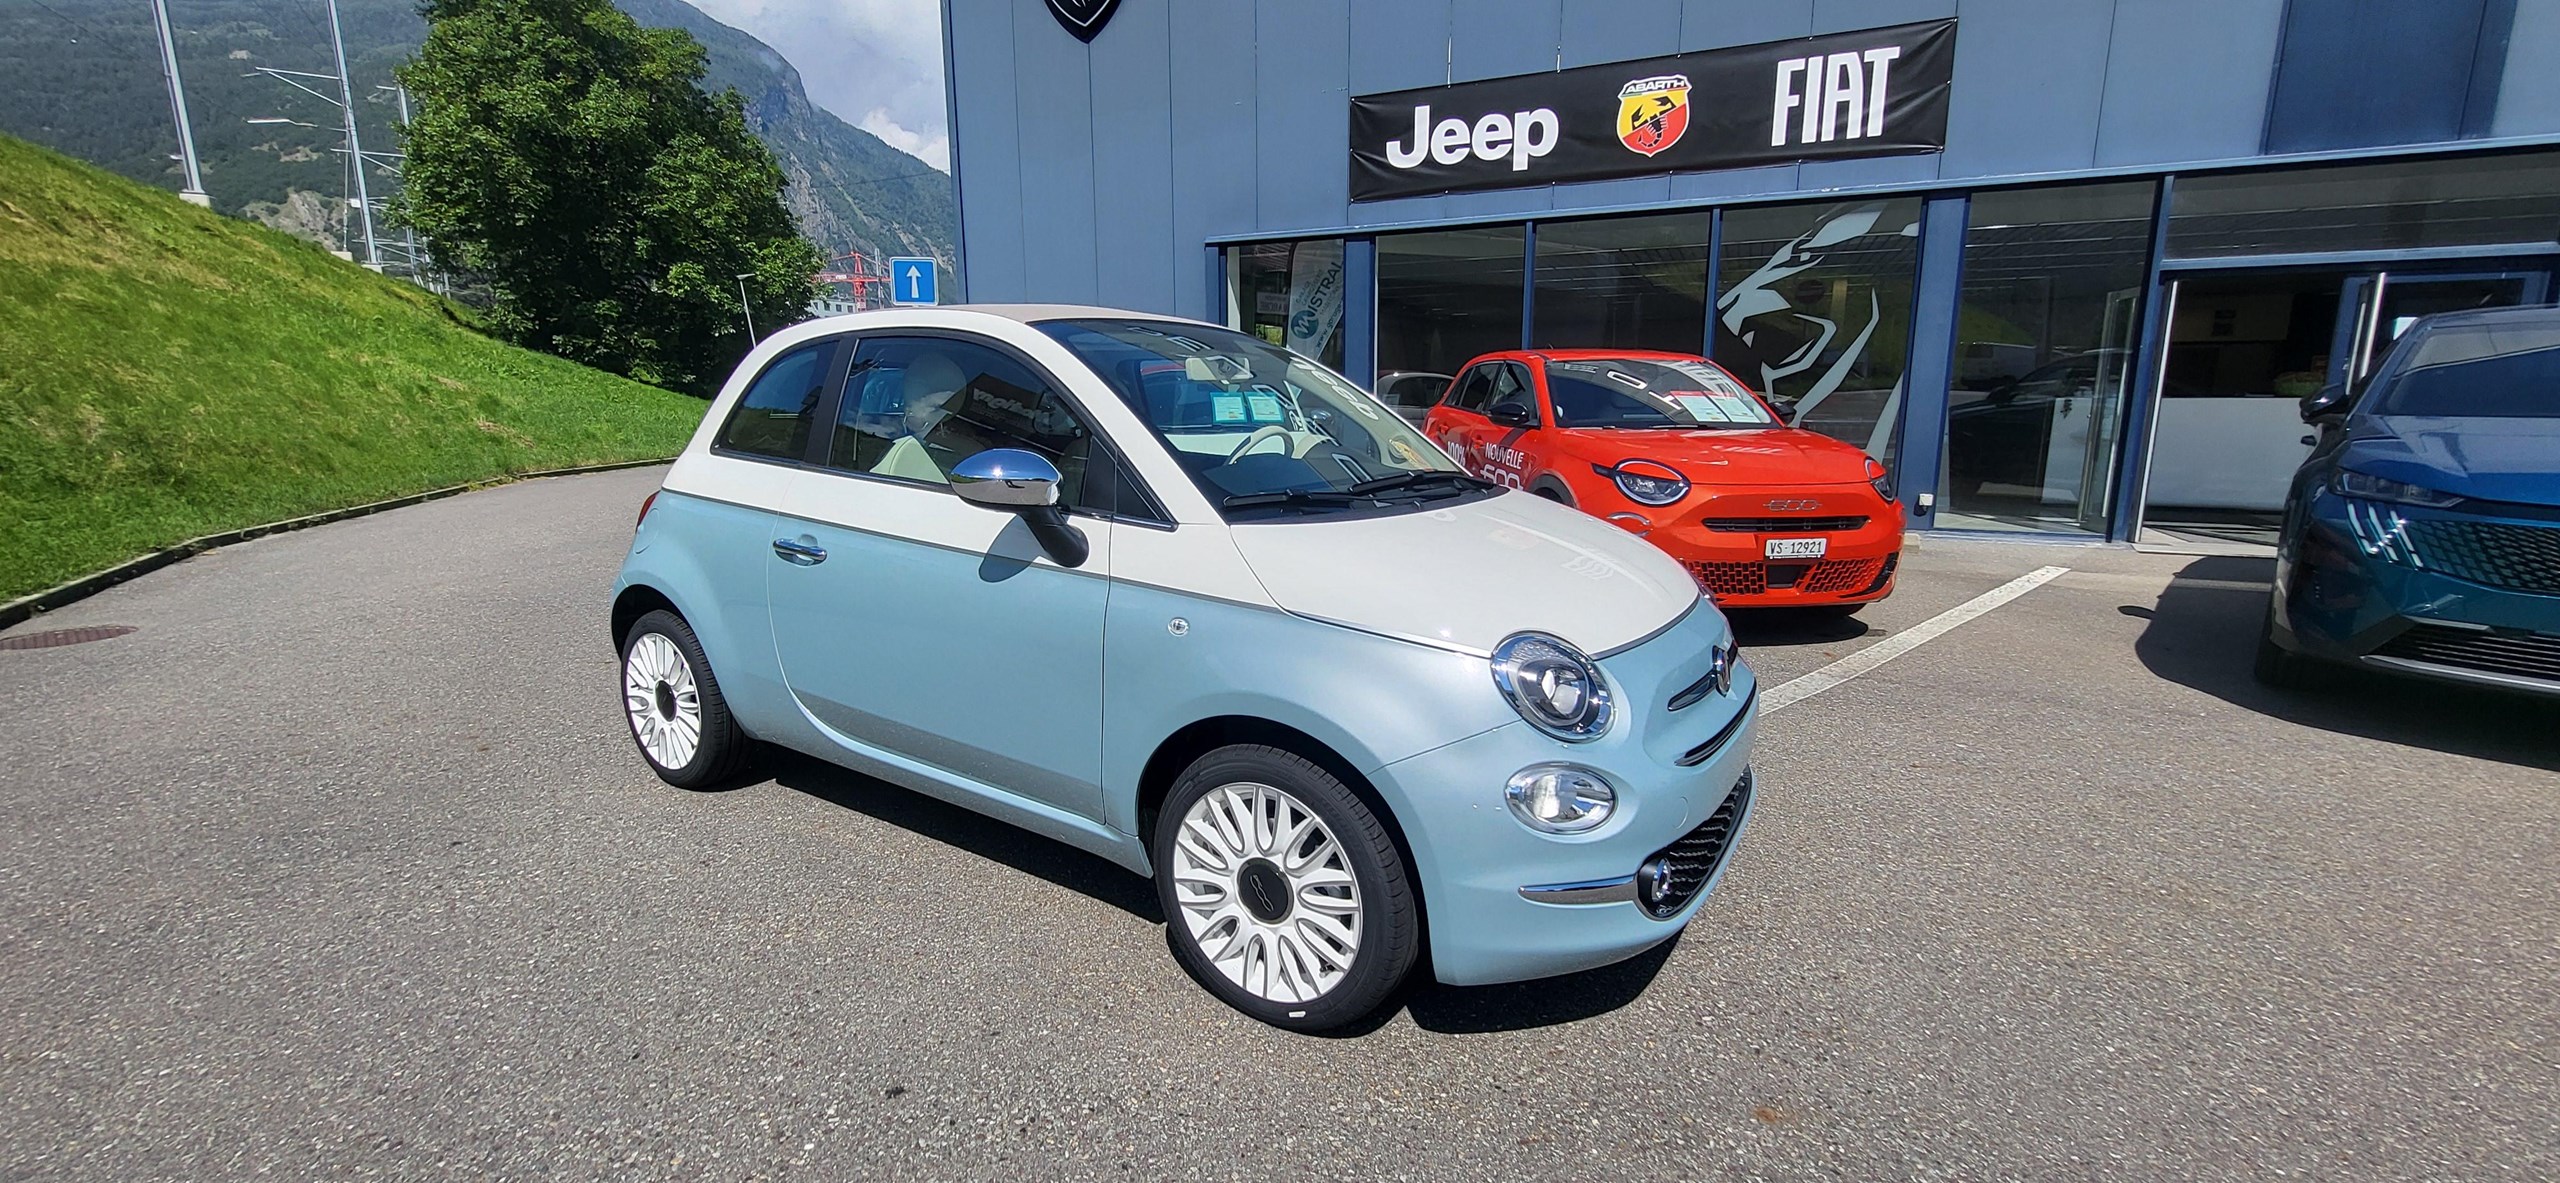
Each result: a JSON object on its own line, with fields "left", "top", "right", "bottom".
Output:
{"left": 768, "top": 333, "right": 1119, "bottom": 819}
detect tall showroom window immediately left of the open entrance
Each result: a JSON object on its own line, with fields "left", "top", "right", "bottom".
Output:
{"left": 1938, "top": 182, "right": 2156, "bottom": 533}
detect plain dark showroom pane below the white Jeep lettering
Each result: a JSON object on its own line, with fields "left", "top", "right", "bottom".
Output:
{"left": 1377, "top": 225, "right": 1528, "bottom": 389}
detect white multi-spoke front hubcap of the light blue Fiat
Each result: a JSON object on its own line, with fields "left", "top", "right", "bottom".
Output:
{"left": 1172, "top": 784, "right": 1362, "bottom": 1004}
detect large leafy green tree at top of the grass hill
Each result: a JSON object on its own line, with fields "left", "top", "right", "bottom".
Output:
{"left": 399, "top": 0, "right": 822, "bottom": 394}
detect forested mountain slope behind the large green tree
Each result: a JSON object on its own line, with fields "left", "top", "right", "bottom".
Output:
{"left": 0, "top": 0, "right": 957, "bottom": 259}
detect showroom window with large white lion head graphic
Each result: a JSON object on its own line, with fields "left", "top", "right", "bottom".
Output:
{"left": 1715, "top": 197, "right": 1920, "bottom": 469}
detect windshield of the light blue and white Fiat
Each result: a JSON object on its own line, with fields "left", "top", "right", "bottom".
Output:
{"left": 1039, "top": 320, "right": 1495, "bottom": 517}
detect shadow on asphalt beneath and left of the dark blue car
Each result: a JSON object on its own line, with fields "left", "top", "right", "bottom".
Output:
{"left": 2117, "top": 556, "right": 2560, "bottom": 771}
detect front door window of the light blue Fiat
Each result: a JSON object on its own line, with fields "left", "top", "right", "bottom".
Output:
{"left": 827, "top": 338, "right": 1114, "bottom": 510}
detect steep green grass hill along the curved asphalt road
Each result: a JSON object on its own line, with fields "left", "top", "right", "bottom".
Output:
{"left": 0, "top": 136, "right": 701, "bottom": 599}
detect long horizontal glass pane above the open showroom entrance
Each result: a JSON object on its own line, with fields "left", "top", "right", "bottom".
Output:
{"left": 2168, "top": 151, "right": 2560, "bottom": 259}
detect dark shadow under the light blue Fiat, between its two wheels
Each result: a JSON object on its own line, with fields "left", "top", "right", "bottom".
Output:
{"left": 763, "top": 748, "right": 1165, "bottom": 924}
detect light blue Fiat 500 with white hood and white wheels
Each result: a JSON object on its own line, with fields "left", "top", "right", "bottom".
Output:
{"left": 612, "top": 307, "right": 1756, "bottom": 1029}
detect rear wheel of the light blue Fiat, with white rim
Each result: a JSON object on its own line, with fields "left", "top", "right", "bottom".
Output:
{"left": 622, "top": 609, "right": 755, "bottom": 789}
